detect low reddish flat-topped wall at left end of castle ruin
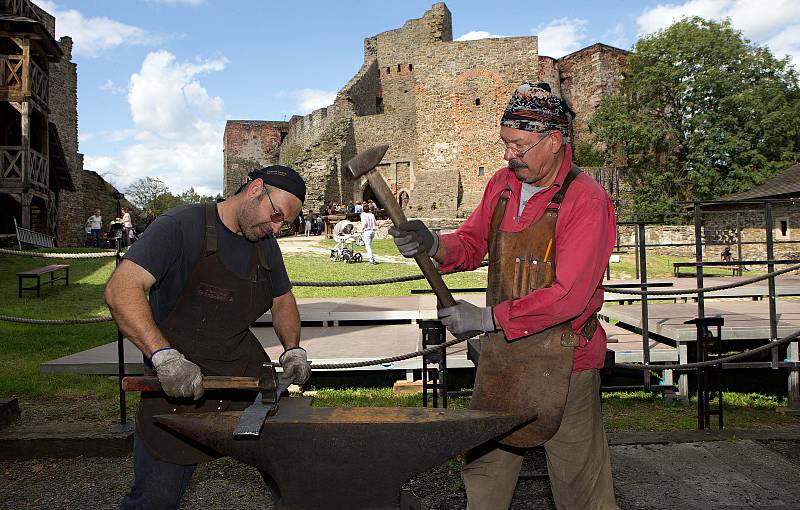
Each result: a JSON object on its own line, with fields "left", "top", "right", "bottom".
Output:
{"left": 223, "top": 120, "right": 289, "bottom": 198}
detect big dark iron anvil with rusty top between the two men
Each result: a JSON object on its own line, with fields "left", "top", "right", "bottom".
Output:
{"left": 155, "top": 397, "right": 535, "bottom": 510}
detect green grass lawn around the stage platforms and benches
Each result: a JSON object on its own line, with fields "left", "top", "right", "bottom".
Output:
{"left": 0, "top": 244, "right": 797, "bottom": 430}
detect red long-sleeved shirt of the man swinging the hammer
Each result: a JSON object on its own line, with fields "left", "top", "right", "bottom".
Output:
{"left": 441, "top": 146, "right": 616, "bottom": 372}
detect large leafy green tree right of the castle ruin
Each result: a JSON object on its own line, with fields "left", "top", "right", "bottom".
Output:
{"left": 589, "top": 17, "right": 800, "bottom": 219}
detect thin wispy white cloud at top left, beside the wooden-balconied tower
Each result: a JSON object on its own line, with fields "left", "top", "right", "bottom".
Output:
{"left": 36, "top": 0, "right": 155, "bottom": 57}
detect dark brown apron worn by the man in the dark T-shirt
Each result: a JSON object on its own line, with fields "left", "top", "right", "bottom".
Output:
{"left": 136, "top": 203, "right": 272, "bottom": 464}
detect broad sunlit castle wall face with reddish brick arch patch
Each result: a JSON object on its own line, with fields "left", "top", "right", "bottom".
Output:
{"left": 411, "top": 37, "right": 538, "bottom": 217}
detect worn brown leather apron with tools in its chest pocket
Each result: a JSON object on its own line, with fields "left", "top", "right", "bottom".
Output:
{"left": 470, "top": 166, "right": 580, "bottom": 448}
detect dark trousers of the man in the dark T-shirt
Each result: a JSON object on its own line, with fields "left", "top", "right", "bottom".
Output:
{"left": 119, "top": 434, "right": 197, "bottom": 510}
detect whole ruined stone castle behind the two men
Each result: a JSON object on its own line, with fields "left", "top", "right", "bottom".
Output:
{"left": 224, "top": 3, "right": 627, "bottom": 218}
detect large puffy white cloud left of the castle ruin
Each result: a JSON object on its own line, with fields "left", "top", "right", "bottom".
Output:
{"left": 82, "top": 50, "right": 228, "bottom": 195}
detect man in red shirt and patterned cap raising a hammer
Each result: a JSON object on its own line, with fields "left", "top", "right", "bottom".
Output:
{"left": 390, "top": 83, "right": 617, "bottom": 510}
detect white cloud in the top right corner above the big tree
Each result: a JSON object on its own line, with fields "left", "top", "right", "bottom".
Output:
{"left": 636, "top": 0, "right": 800, "bottom": 65}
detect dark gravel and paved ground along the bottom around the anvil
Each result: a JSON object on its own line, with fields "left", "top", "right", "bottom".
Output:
{"left": 0, "top": 440, "right": 800, "bottom": 510}
